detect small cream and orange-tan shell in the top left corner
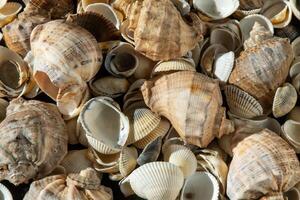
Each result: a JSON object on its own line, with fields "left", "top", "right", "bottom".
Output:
{"left": 0, "top": 2, "right": 22, "bottom": 28}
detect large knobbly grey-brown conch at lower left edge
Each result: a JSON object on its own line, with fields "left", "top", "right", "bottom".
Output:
{"left": 0, "top": 98, "right": 68, "bottom": 185}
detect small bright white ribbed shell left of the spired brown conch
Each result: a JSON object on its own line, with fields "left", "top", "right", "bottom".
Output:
{"left": 214, "top": 51, "right": 234, "bottom": 82}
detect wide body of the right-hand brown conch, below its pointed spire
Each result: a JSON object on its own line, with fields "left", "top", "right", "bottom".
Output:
{"left": 229, "top": 38, "right": 293, "bottom": 112}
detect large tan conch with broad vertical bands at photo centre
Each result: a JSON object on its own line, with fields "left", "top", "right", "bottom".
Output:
{"left": 141, "top": 71, "right": 234, "bottom": 147}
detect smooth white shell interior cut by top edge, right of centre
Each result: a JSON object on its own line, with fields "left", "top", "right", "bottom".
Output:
{"left": 193, "top": 0, "right": 240, "bottom": 20}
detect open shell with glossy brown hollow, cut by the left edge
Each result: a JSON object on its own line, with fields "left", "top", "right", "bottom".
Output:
{"left": 0, "top": 46, "right": 36, "bottom": 98}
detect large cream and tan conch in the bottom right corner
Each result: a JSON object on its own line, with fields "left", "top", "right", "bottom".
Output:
{"left": 227, "top": 129, "right": 300, "bottom": 200}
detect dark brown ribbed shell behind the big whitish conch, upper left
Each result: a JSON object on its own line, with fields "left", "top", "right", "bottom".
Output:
{"left": 66, "top": 12, "right": 120, "bottom": 42}
